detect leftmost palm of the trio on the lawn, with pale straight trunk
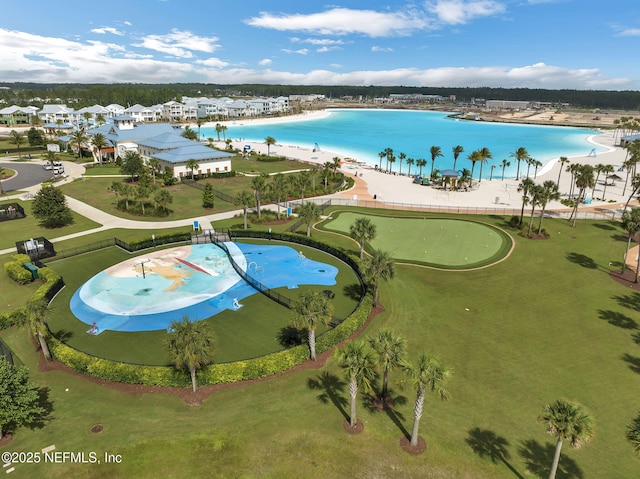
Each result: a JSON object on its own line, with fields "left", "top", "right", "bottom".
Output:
{"left": 335, "top": 341, "right": 376, "bottom": 427}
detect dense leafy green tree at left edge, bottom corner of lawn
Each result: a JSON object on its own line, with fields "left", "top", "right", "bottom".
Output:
{"left": 0, "top": 355, "right": 46, "bottom": 439}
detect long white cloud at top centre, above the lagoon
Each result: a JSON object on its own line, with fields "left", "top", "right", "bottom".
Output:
{"left": 245, "top": 8, "right": 430, "bottom": 37}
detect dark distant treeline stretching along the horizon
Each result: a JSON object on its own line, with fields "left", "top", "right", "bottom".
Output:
{"left": 0, "top": 83, "right": 640, "bottom": 111}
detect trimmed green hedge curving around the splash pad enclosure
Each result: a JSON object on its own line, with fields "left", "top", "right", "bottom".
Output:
{"left": 41, "top": 232, "right": 373, "bottom": 387}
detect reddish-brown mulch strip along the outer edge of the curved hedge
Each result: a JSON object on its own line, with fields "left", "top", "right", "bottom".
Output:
{"left": 37, "top": 305, "right": 384, "bottom": 406}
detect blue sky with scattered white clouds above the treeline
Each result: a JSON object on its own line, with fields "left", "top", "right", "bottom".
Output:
{"left": 0, "top": 0, "right": 640, "bottom": 90}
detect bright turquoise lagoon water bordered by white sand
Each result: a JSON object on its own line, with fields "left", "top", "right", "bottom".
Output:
{"left": 202, "top": 109, "right": 606, "bottom": 177}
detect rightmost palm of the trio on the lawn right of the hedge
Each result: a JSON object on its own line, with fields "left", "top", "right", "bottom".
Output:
{"left": 404, "top": 352, "right": 452, "bottom": 447}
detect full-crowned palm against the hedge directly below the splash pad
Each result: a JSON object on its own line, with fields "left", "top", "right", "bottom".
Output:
{"left": 165, "top": 316, "right": 213, "bottom": 392}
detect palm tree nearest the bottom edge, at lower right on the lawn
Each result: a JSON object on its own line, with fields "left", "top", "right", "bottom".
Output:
{"left": 538, "top": 399, "right": 595, "bottom": 479}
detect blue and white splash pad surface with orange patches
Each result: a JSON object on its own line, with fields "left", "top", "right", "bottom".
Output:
{"left": 70, "top": 243, "right": 338, "bottom": 334}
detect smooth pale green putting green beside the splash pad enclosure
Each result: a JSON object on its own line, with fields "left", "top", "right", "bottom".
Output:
{"left": 323, "top": 211, "right": 513, "bottom": 269}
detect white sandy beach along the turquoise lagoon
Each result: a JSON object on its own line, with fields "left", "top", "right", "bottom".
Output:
{"left": 199, "top": 111, "right": 637, "bottom": 211}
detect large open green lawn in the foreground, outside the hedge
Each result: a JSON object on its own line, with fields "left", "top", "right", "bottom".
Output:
{"left": 1, "top": 216, "right": 640, "bottom": 479}
